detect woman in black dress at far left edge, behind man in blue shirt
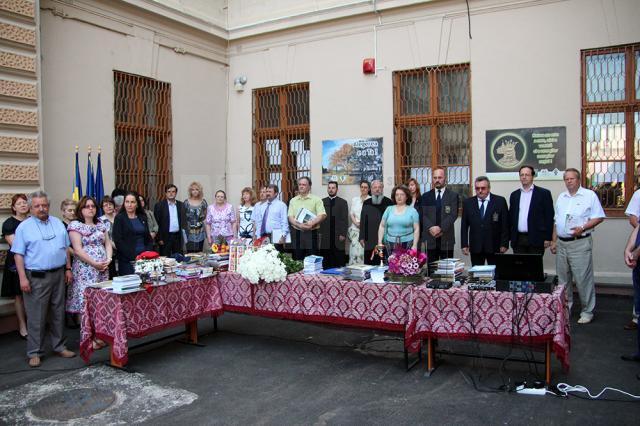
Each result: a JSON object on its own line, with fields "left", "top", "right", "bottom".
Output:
{"left": 1, "top": 194, "right": 29, "bottom": 339}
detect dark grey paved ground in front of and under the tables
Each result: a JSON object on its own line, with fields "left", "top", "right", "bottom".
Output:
{"left": 0, "top": 296, "right": 640, "bottom": 426}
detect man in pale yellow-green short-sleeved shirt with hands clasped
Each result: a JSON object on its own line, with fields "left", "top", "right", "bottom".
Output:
{"left": 289, "top": 176, "right": 327, "bottom": 260}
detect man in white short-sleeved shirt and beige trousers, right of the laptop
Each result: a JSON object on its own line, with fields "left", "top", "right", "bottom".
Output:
{"left": 551, "top": 168, "right": 605, "bottom": 324}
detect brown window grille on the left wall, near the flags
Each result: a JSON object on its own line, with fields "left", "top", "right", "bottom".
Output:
{"left": 113, "top": 71, "right": 173, "bottom": 206}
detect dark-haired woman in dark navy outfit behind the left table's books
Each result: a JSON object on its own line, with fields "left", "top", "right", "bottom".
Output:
{"left": 113, "top": 191, "right": 153, "bottom": 275}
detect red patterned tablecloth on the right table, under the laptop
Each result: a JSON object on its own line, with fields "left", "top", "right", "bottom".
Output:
{"left": 405, "top": 286, "right": 570, "bottom": 369}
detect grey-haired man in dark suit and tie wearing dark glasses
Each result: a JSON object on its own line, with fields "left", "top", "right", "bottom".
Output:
{"left": 460, "top": 176, "right": 509, "bottom": 265}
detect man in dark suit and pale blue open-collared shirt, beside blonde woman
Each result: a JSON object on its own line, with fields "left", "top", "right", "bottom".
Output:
{"left": 153, "top": 183, "right": 185, "bottom": 256}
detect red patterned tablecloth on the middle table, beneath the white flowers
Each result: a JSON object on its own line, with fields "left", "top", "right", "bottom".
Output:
{"left": 225, "top": 272, "right": 411, "bottom": 331}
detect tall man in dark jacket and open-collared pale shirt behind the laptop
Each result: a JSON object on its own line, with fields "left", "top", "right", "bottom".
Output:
{"left": 509, "top": 166, "right": 554, "bottom": 255}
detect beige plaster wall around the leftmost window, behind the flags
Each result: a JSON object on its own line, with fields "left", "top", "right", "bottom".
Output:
{"left": 42, "top": 0, "right": 228, "bottom": 212}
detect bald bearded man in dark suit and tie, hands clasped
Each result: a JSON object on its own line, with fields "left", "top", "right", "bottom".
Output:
{"left": 417, "top": 167, "right": 460, "bottom": 262}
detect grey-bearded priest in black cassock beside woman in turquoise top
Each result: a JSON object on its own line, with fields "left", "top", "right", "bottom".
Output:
{"left": 359, "top": 180, "right": 393, "bottom": 265}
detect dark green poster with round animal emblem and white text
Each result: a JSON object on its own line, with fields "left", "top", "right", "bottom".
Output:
{"left": 486, "top": 127, "right": 567, "bottom": 180}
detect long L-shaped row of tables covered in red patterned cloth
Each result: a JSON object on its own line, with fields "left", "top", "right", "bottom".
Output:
{"left": 80, "top": 272, "right": 570, "bottom": 382}
